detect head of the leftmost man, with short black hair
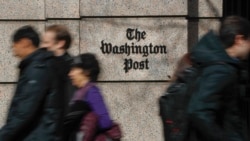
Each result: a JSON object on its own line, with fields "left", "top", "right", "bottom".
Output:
{"left": 12, "top": 25, "right": 40, "bottom": 59}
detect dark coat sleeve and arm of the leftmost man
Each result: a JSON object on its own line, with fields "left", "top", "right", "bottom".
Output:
{"left": 0, "top": 68, "right": 49, "bottom": 141}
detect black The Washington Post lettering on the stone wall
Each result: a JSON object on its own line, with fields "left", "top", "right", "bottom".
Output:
{"left": 100, "top": 28, "right": 167, "bottom": 73}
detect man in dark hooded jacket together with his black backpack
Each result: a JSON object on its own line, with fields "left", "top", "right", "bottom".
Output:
{"left": 160, "top": 16, "right": 250, "bottom": 141}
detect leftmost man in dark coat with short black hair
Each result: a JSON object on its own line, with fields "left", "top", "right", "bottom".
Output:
{"left": 0, "top": 26, "right": 62, "bottom": 141}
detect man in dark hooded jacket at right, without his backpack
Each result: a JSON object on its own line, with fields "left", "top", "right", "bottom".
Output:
{"left": 188, "top": 16, "right": 250, "bottom": 141}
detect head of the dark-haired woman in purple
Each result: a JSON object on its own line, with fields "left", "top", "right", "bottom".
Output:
{"left": 69, "top": 53, "right": 100, "bottom": 87}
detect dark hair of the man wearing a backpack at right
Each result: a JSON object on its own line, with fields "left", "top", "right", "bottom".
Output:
{"left": 219, "top": 16, "right": 250, "bottom": 48}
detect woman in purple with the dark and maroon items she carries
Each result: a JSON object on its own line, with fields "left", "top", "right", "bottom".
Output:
{"left": 64, "top": 53, "right": 121, "bottom": 141}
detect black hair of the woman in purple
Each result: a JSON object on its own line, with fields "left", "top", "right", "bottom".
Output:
{"left": 71, "top": 53, "right": 100, "bottom": 82}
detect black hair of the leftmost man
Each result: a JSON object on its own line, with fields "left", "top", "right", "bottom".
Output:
{"left": 12, "top": 25, "right": 40, "bottom": 47}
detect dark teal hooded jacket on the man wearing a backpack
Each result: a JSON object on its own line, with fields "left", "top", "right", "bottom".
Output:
{"left": 188, "top": 32, "right": 246, "bottom": 141}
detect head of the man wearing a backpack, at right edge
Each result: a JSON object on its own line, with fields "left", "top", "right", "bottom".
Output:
{"left": 219, "top": 16, "right": 250, "bottom": 59}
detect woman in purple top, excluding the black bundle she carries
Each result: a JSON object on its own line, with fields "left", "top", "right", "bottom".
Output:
{"left": 69, "top": 53, "right": 113, "bottom": 141}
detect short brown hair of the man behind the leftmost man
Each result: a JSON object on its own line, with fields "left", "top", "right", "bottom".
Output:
{"left": 45, "top": 25, "right": 72, "bottom": 49}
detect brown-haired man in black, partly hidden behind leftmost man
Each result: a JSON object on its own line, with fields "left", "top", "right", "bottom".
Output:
{"left": 41, "top": 24, "right": 75, "bottom": 113}
